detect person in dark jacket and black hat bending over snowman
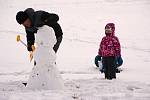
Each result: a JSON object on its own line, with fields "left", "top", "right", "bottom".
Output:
{"left": 16, "top": 8, "right": 63, "bottom": 52}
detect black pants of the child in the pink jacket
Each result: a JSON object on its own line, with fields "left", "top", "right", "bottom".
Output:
{"left": 102, "top": 57, "right": 116, "bottom": 79}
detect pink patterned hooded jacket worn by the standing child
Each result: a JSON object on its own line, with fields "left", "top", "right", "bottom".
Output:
{"left": 98, "top": 23, "right": 121, "bottom": 57}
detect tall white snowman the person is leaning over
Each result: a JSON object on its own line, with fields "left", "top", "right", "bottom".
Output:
{"left": 26, "top": 25, "right": 64, "bottom": 90}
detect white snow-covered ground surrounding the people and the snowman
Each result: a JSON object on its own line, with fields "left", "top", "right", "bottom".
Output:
{"left": 0, "top": 0, "right": 150, "bottom": 100}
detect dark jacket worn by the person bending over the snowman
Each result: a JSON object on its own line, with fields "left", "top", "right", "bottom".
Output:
{"left": 24, "top": 8, "right": 63, "bottom": 51}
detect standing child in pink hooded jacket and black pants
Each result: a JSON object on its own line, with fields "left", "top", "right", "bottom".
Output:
{"left": 98, "top": 23, "right": 121, "bottom": 80}
